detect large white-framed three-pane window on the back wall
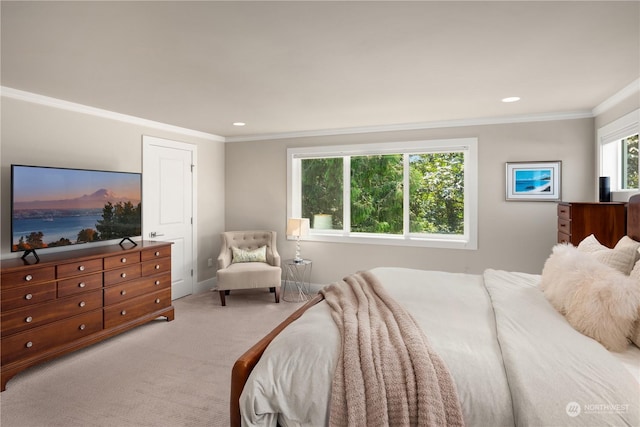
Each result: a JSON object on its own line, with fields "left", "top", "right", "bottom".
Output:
{"left": 287, "top": 138, "right": 478, "bottom": 249}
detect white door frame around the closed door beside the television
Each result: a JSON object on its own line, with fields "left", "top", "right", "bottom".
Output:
{"left": 142, "top": 135, "right": 198, "bottom": 294}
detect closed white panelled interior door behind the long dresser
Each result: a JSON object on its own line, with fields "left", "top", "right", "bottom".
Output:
{"left": 142, "top": 136, "right": 196, "bottom": 299}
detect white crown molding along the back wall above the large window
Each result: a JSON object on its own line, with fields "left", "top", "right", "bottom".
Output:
{"left": 225, "top": 111, "right": 593, "bottom": 142}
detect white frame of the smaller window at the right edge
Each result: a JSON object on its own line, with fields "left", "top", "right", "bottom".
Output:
{"left": 594, "top": 109, "right": 640, "bottom": 200}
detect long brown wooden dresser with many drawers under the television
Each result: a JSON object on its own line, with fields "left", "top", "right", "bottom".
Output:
{"left": 0, "top": 242, "right": 174, "bottom": 391}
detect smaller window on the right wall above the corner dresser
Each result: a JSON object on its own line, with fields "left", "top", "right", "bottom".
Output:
{"left": 598, "top": 110, "right": 640, "bottom": 193}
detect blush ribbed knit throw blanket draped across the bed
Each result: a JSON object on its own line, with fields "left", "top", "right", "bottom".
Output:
{"left": 321, "top": 272, "right": 464, "bottom": 427}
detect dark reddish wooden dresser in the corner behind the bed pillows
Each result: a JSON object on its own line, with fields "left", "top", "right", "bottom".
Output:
{"left": 558, "top": 202, "right": 627, "bottom": 248}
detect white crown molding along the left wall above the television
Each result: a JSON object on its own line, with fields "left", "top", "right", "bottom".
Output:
{"left": 0, "top": 86, "right": 225, "bottom": 142}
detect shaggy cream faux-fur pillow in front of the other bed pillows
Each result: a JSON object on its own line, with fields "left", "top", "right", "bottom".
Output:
{"left": 540, "top": 245, "right": 640, "bottom": 351}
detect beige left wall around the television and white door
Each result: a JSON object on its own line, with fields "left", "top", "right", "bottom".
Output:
{"left": 0, "top": 97, "right": 225, "bottom": 282}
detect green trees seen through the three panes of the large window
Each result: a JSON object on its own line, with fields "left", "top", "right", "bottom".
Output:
{"left": 301, "top": 152, "right": 464, "bottom": 234}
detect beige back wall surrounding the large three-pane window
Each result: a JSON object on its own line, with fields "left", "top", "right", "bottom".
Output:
{"left": 225, "top": 119, "right": 595, "bottom": 283}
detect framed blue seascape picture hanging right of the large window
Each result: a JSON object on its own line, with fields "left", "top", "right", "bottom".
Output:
{"left": 507, "top": 161, "right": 562, "bottom": 201}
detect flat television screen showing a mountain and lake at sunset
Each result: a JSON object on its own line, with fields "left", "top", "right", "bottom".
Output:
{"left": 11, "top": 165, "right": 142, "bottom": 252}
